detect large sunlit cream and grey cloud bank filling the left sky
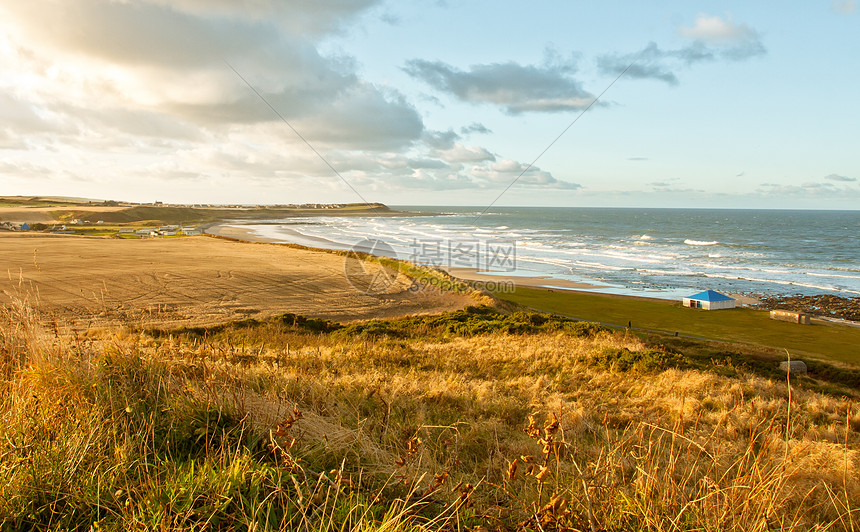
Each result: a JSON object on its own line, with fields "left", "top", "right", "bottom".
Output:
{"left": 0, "top": 0, "right": 532, "bottom": 200}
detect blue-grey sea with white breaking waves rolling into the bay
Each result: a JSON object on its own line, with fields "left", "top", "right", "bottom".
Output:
{"left": 230, "top": 206, "right": 860, "bottom": 297}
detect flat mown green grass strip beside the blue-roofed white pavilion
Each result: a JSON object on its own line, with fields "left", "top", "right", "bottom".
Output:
{"left": 490, "top": 287, "right": 860, "bottom": 366}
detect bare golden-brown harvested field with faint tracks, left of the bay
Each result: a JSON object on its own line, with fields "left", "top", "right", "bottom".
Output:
{"left": 0, "top": 233, "right": 473, "bottom": 326}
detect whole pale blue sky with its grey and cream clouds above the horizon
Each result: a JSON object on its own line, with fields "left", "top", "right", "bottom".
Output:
{"left": 0, "top": 0, "right": 860, "bottom": 209}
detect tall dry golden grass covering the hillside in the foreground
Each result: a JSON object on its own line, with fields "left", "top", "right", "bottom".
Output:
{"left": 0, "top": 297, "right": 860, "bottom": 532}
